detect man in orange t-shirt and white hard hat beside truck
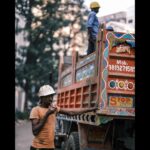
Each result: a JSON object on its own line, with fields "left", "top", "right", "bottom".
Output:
{"left": 30, "top": 85, "right": 97, "bottom": 150}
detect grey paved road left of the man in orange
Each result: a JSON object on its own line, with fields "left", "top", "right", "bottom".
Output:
{"left": 15, "top": 121, "right": 61, "bottom": 150}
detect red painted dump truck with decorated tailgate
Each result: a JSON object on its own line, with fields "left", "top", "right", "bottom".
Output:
{"left": 55, "top": 24, "right": 135, "bottom": 150}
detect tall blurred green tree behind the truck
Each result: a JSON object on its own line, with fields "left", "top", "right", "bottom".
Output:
{"left": 15, "top": 0, "right": 86, "bottom": 110}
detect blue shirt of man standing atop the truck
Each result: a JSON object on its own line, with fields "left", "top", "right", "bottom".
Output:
{"left": 86, "top": 11, "right": 100, "bottom": 38}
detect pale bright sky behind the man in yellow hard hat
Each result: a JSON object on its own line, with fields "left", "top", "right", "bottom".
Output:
{"left": 84, "top": 0, "right": 135, "bottom": 17}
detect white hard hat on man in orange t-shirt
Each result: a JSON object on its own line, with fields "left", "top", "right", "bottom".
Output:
{"left": 38, "top": 85, "right": 55, "bottom": 97}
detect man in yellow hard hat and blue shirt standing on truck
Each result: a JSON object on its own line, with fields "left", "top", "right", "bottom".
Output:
{"left": 87, "top": 2, "right": 100, "bottom": 55}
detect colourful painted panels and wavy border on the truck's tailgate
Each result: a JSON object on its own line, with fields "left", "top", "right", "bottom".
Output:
{"left": 100, "top": 32, "right": 135, "bottom": 116}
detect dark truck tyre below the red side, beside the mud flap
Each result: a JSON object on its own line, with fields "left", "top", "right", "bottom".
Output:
{"left": 66, "top": 132, "right": 80, "bottom": 150}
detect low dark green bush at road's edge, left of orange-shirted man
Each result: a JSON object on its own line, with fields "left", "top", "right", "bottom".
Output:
{"left": 15, "top": 110, "right": 29, "bottom": 120}
